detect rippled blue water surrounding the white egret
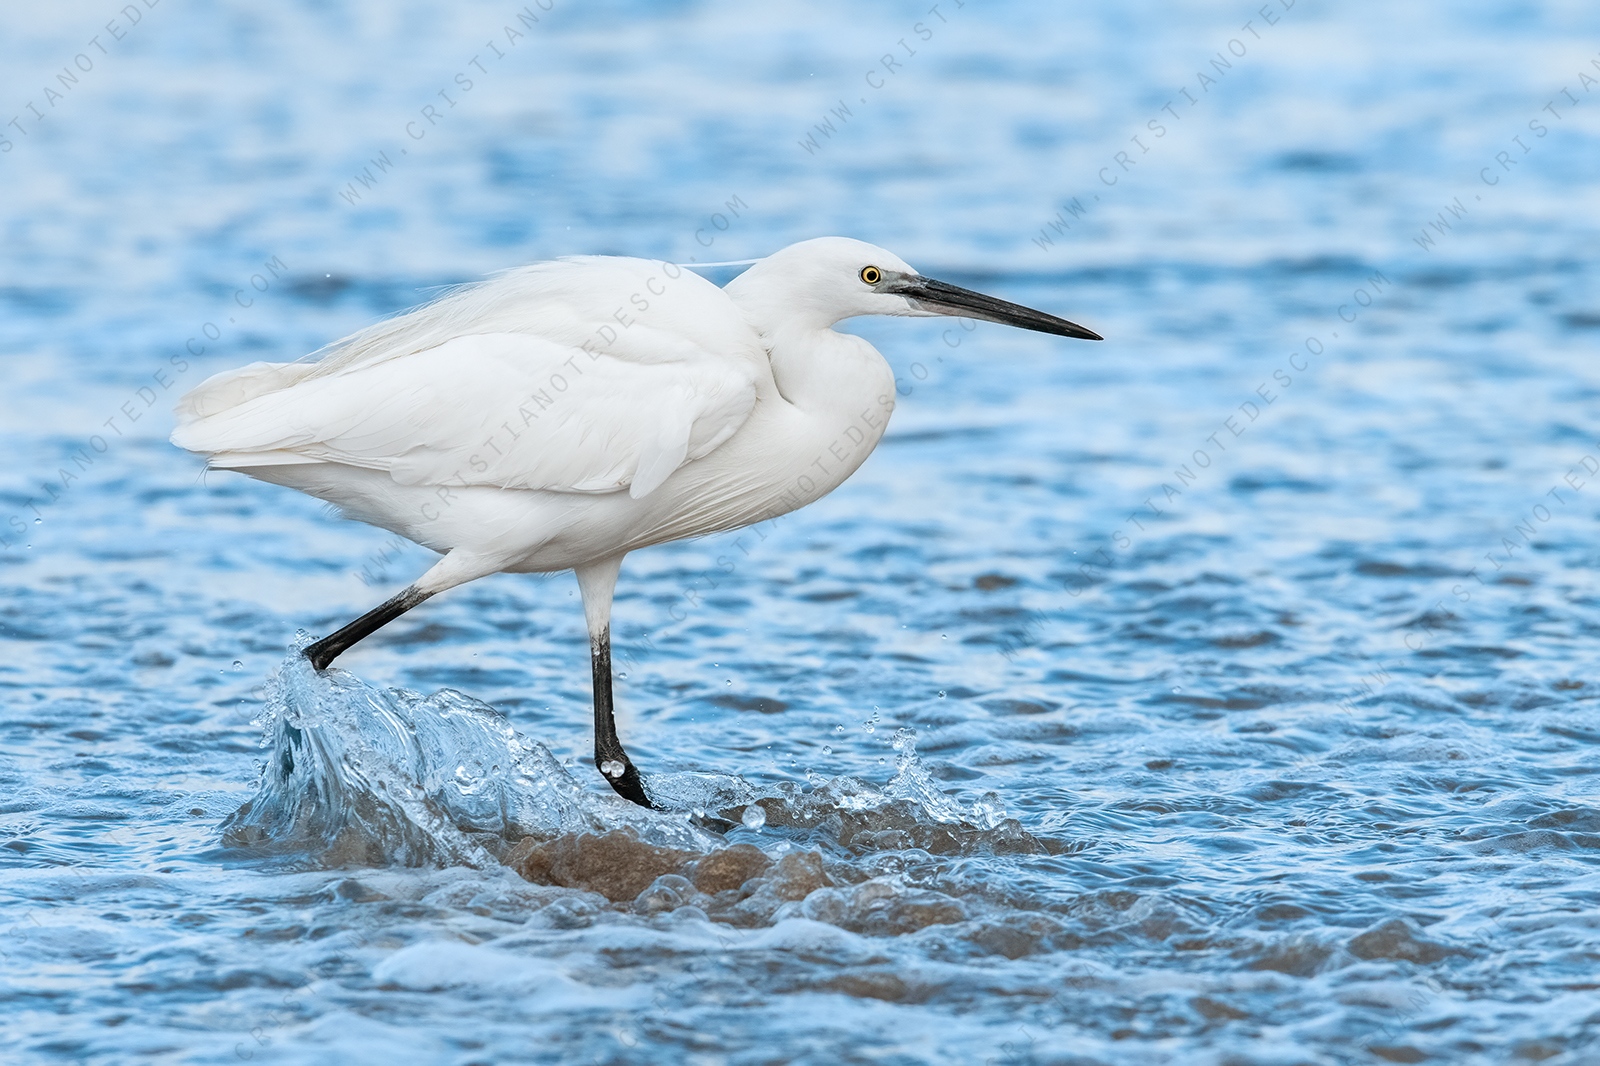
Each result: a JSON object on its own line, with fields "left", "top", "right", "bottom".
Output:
{"left": 0, "top": 0, "right": 1600, "bottom": 1063}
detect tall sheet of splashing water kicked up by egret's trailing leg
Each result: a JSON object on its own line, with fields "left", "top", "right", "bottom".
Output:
{"left": 222, "top": 647, "right": 714, "bottom": 866}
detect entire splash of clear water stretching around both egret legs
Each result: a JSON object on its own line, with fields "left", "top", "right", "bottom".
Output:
{"left": 222, "top": 639, "right": 1019, "bottom": 868}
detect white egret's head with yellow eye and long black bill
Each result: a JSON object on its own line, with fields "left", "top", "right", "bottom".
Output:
{"left": 728, "top": 237, "right": 1101, "bottom": 341}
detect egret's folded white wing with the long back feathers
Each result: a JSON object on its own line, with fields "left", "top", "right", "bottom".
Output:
{"left": 173, "top": 259, "right": 766, "bottom": 498}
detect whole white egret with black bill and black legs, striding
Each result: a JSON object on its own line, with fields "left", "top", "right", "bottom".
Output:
{"left": 171, "top": 237, "right": 1101, "bottom": 807}
